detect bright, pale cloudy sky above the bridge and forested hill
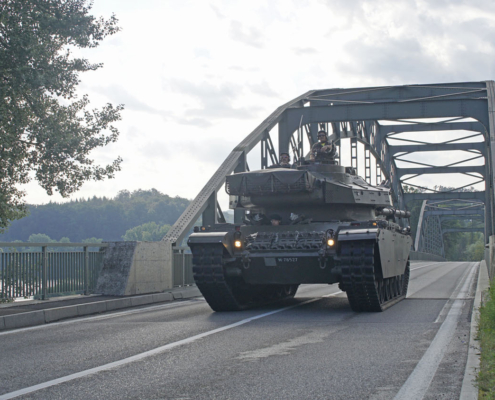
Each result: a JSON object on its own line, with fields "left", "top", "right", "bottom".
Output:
{"left": 22, "top": 0, "right": 495, "bottom": 204}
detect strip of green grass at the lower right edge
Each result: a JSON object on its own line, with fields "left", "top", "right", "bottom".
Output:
{"left": 477, "top": 284, "right": 495, "bottom": 400}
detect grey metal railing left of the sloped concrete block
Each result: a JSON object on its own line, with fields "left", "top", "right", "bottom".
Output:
{"left": 0, "top": 242, "right": 108, "bottom": 302}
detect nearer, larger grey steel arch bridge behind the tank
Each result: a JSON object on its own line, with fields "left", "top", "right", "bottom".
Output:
{"left": 162, "top": 81, "right": 495, "bottom": 262}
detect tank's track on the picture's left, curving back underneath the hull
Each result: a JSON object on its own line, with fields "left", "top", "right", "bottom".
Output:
{"left": 192, "top": 244, "right": 299, "bottom": 311}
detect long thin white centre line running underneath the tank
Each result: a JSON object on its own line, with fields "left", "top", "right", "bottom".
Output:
{"left": 0, "top": 298, "right": 332, "bottom": 400}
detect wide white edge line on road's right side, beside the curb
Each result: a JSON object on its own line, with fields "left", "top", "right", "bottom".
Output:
{"left": 394, "top": 263, "right": 477, "bottom": 400}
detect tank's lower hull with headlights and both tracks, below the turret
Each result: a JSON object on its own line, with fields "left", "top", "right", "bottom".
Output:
{"left": 188, "top": 221, "right": 412, "bottom": 311}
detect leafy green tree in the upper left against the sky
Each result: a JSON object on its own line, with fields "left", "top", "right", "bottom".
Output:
{"left": 0, "top": 0, "right": 123, "bottom": 232}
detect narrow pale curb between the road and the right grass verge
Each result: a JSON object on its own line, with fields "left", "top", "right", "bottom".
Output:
{"left": 459, "top": 260, "right": 490, "bottom": 400}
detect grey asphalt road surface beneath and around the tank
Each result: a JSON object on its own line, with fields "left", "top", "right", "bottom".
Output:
{"left": 0, "top": 262, "right": 479, "bottom": 400}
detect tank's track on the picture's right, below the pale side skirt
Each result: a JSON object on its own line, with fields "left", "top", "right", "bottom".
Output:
{"left": 340, "top": 240, "right": 410, "bottom": 312}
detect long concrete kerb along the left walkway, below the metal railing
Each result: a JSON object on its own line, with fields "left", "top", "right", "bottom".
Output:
{"left": 0, "top": 286, "right": 202, "bottom": 331}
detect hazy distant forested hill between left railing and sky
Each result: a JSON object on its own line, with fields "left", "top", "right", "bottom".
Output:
{"left": 0, "top": 189, "right": 190, "bottom": 242}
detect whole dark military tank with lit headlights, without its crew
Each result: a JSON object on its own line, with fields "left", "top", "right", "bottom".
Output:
{"left": 188, "top": 163, "right": 412, "bottom": 312}
